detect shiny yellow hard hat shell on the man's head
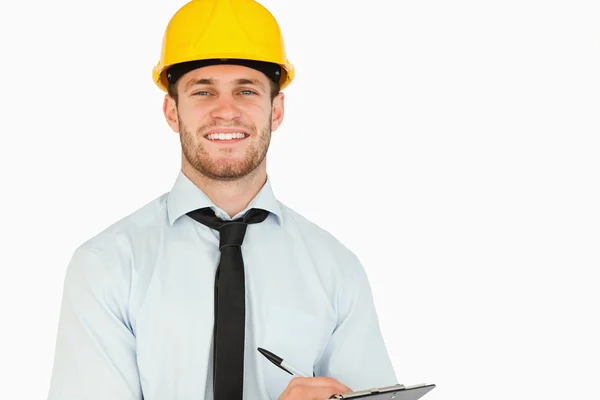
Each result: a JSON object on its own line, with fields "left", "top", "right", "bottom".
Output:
{"left": 152, "top": 0, "right": 294, "bottom": 92}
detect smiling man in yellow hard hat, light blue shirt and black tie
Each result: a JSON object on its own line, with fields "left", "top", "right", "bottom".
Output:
{"left": 49, "top": 0, "right": 397, "bottom": 400}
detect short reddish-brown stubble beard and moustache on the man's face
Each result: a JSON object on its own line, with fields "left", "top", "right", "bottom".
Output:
{"left": 179, "top": 115, "right": 271, "bottom": 181}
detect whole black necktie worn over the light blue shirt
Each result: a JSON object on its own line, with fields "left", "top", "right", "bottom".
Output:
{"left": 187, "top": 208, "right": 269, "bottom": 400}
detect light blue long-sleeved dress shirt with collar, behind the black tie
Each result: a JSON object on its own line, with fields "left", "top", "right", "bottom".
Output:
{"left": 48, "top": 172, "right": 397, "bottom": 400}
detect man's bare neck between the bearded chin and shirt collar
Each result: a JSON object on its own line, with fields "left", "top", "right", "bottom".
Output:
{"left": 181, "top": 163, "right": 267, "bottom": 218}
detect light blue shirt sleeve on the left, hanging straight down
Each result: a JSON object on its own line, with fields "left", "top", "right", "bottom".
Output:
{"left": 48, "top": 248, "right": 143, "bottom": 400}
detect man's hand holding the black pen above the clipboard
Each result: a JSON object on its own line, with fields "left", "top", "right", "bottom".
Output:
{"left": 278, "top": 377, "right": 352, "bottom": 400}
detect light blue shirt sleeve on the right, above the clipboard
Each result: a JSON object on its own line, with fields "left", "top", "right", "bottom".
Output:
{"left": 315, "top": 255, "right": 398, "bottom": 391}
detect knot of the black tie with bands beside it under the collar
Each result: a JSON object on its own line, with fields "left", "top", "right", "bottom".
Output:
{"left": 187, "top": 207, "right": 269, "bottom": 250}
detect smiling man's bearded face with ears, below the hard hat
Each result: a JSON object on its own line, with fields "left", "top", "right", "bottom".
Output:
{"left": 164, "top": 65, "right": 283, "bottom": 180}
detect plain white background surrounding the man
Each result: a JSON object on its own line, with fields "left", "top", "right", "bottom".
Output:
{"left": 0, "top": 0, "right": 600, "bottom": 400}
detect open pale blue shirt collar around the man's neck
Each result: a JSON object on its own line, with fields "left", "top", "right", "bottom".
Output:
{"left": 167, "top": 170, "right": 283, "bottom": 225}
